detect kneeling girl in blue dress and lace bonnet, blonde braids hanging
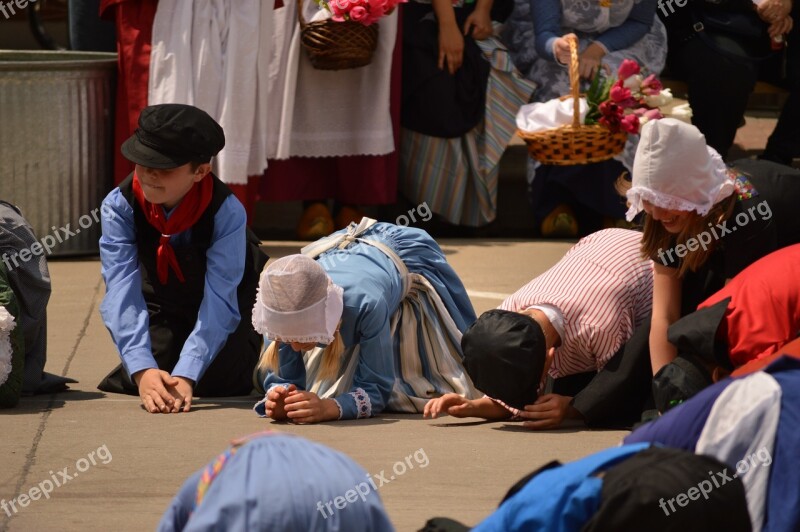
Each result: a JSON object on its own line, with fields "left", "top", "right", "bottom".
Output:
{"left": 253, "top": 218, "right": 477, "bottom": 423}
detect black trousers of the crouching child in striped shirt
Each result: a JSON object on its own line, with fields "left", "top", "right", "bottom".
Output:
{"left": 553, "top": 316, "right": 654, "bottom": 428}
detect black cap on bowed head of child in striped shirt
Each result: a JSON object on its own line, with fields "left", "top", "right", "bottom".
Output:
{"left": 461, "top": 309, "right": 546, "bottom": 409}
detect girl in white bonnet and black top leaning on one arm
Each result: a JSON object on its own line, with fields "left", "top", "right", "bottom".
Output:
{"left": 626, "top": 118, "right": 800, "bottom": 374}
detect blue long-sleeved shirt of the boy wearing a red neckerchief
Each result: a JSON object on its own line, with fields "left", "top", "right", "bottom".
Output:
{"left": 100, "top": 188, "right": 247, "bottom": 383}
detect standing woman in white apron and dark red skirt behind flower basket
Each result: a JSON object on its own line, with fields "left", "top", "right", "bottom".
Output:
{"left": 260, "top": 0, "right": 401, "bottom": 240}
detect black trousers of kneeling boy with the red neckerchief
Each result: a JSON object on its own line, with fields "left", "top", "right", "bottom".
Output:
{"left": 97, "top": 302, "right": 262, "bottom": 397}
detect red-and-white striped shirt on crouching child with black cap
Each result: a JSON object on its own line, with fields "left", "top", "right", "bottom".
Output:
{"left": 500, "top": 229, "right": 653, "bottom": 378}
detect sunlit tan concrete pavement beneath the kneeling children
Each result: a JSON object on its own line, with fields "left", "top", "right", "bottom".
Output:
{"left": 0, "top": 240, "right": 626, "bottom": 532}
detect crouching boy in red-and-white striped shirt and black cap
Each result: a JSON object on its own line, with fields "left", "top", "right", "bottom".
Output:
{"left": 424, "top": 229, "right": 653, "bottom": 429}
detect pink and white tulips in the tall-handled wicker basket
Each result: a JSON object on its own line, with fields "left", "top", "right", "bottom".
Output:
{"left": 585, "top": 59, "right": 672, "bottom": 135}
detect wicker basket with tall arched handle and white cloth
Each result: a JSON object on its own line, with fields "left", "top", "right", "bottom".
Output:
{"left": 517, "top": 38, "right": 628, "bottom": 166}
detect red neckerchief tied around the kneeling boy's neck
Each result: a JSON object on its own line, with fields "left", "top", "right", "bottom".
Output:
{"left": 133, "top": 172, "right": 214, "bottom": 285}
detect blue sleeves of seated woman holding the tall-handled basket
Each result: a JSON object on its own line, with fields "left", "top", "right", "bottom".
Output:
{"left": 530, "top": 0, "right": 657, "bottom": 61}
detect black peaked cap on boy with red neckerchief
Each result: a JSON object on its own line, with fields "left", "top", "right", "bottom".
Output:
{"left": 121, "top": 103, "right": 225, "bottom": 169}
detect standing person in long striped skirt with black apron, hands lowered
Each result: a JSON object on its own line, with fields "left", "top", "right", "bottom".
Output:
{"left": 400, "top": 0, "right": 536, "bottom": 227}
